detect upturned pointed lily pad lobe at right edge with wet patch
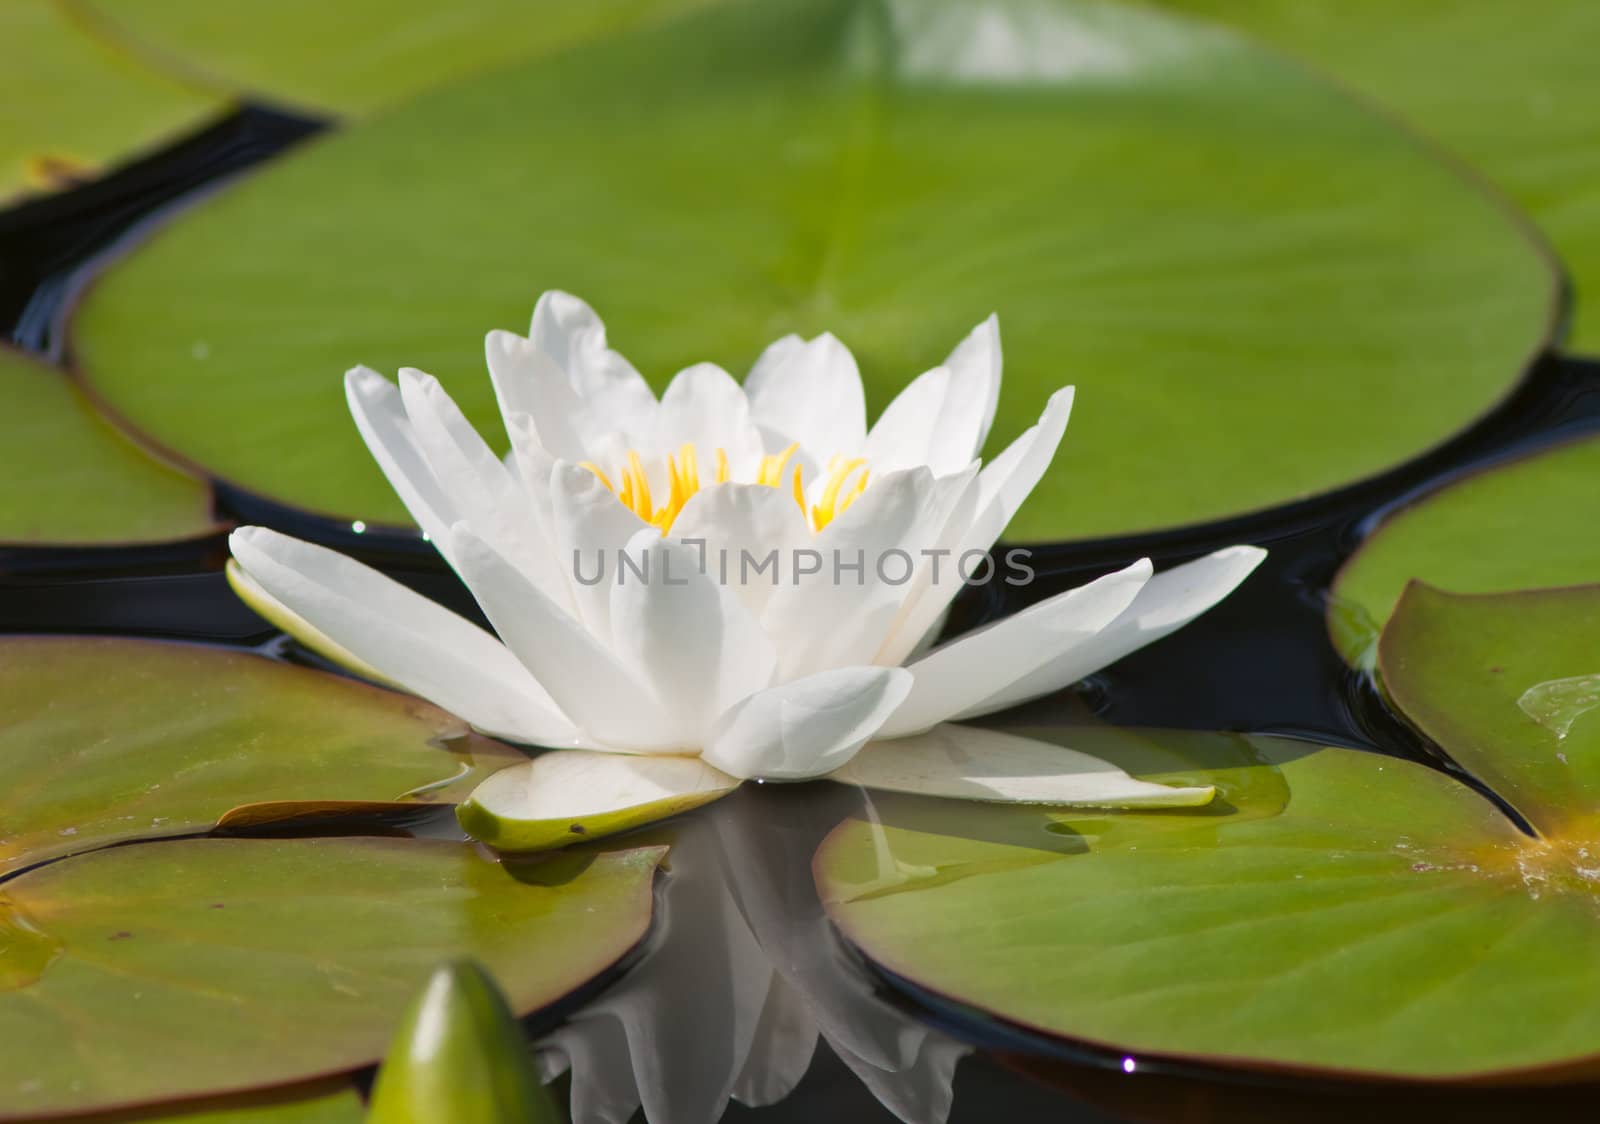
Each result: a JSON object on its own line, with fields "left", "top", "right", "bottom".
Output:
{"left": 1378, "top": 584, "right": 1600, "bottom": 838}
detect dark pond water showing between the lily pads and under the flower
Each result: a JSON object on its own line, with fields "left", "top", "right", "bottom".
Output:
{"left": 0, "top": 109, "right": 1600, "bottom": 1124}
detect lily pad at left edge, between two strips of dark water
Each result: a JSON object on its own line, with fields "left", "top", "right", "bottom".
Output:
{"left": 0, "top": 350, "right": 218, "bottom": 546}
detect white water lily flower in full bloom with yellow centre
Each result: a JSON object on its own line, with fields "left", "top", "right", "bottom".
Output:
{"left": 229, "top": 293, "right": 1264, "bottom": 825}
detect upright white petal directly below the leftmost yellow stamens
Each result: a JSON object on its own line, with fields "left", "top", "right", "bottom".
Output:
{"left": 546, "top": 461, "right": 646, "bottom": 645}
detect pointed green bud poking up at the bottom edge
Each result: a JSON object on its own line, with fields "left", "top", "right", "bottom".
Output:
{"left": 368, "top": 961, "right": 560, "bottom": 1124}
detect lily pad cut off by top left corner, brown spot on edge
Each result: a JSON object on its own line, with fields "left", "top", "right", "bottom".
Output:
{"left": 0, "top": 0, "right": 224, "bottom": 203}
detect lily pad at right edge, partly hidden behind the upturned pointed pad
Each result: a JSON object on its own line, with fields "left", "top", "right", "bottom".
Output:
{"left": 1328, "top": 437, "right": 1600, "bottom": 666}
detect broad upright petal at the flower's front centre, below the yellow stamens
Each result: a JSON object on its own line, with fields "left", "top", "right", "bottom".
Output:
{"left": 611, "top": 528, "right": 778, "bottom": 748}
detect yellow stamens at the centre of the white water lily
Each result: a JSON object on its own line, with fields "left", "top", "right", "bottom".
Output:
{"left": 579, "top": 442, "right": 867, "bottom": 535}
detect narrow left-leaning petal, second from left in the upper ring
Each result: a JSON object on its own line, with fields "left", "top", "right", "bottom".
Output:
{"left": 400, "top": 367, "right": 570, "bottom": 605}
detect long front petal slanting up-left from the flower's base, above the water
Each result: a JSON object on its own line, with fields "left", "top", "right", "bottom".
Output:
{"left": 450, "top": 524, "right": 686, "bottom": 753}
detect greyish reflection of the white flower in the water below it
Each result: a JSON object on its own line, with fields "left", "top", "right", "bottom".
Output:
{"left": 539, "top": 785, "right": 971, "bottom": 1124}
